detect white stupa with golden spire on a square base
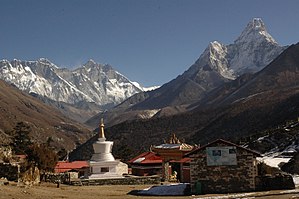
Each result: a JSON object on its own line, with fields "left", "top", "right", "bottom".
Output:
{"left": 88, "top": 119, "right": 128, "bottom": 179}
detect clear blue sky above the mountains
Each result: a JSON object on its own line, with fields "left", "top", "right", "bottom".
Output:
{"left": 0, "top": 0, "right": 299, "bottom": 86}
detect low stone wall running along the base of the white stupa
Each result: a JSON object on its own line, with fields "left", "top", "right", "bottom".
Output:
{"left": 70, "top": 176, "right": 161, "bottom": 186}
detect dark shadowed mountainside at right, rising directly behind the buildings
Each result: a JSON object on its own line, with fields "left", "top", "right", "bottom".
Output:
{"left": 69, "top": 43, "right": 299, "bottom": 162}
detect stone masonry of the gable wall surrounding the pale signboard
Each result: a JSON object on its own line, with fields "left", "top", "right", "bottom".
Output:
{"left": 190, "top": 143, "right": 257, "bottom": 193}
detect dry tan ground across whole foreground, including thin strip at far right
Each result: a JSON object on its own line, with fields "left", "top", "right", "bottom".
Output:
{"left": 0, "top": 183, "right": 299, "bottom": 199}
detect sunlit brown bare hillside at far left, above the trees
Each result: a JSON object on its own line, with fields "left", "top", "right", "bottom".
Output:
{"left": 0, "top": 80, "right": 91, "bottom": 150}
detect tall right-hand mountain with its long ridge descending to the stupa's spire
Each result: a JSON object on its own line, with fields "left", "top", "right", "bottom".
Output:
{"left": 87, "top": 18, "right": 286, "bottom": 127}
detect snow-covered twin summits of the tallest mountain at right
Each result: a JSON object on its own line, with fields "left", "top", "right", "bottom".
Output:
{"left": 184, "top": 18, "right": 286, "bottom": 96}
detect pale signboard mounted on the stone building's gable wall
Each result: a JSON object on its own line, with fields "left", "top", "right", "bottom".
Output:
{"left": 206, "top": 146, "right": 237, "bottom": 166}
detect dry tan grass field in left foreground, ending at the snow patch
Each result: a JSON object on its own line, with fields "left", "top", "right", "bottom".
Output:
{"left": 0, "top": 183, "right": 187, "bottom": 199}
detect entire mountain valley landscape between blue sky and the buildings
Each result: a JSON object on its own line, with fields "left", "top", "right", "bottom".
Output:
{"left": 0, "top": 18, "right": 299, "bottom": 182}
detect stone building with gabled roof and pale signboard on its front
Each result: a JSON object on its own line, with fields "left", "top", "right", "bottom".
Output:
{"left": 185, "top": 139, "right": 259, "bottom": 194}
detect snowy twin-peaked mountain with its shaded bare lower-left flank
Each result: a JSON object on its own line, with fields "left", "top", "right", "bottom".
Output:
{"left": 142, "top": 19, "right": 285, "bottom": 109}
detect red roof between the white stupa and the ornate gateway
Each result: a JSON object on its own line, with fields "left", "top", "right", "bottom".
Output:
{"left": 128, "top": 152, "right": 162, "bottom": 164}
